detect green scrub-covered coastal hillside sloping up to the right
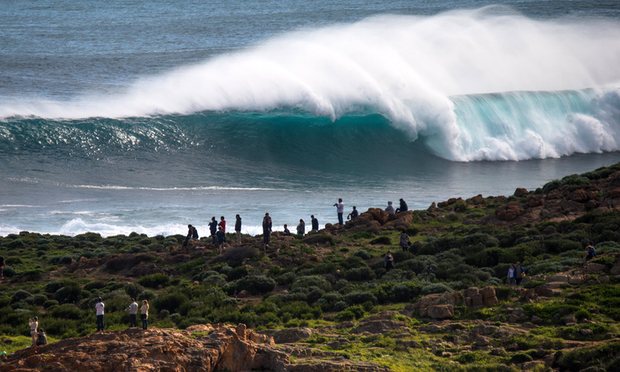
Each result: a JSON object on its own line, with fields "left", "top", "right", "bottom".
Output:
{"left": 0, "top": 164, "right": 620, "bottom": 371}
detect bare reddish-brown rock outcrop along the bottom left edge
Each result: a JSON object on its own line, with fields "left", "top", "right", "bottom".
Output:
{"left": 0, "top": 324, "right": 289, "bottom": 371}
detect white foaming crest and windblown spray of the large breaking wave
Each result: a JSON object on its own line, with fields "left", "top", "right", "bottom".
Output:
{"left": 0, "top": 7, "right": 620, "bottom": 161}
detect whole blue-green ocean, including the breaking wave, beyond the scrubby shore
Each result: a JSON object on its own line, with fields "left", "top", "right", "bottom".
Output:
{"left": 0, "top": 0, "right": 620, "bottom": 235}
